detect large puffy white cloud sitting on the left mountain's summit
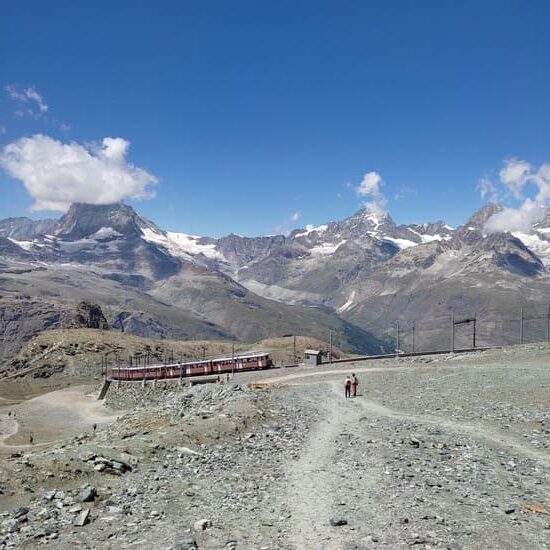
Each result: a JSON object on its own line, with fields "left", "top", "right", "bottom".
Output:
{"left": 0, "top": 134, "right": 158, "bottom": 212}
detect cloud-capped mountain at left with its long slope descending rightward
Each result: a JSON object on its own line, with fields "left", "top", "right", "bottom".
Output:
{"left": 0, "top": 204, "right": 388, "bottom": 362}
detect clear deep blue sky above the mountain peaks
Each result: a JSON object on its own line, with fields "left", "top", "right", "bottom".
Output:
{"left": 0, "top": 0, "right": 550, "bottom": 235}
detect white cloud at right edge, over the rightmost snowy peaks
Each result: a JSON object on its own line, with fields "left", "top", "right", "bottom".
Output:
{"left": 486, "top": 159, "right": 550, "bottom": 233}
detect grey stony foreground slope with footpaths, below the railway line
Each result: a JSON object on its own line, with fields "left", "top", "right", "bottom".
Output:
{"left": 0, "top": 345, "right": 550, "bottom": 550}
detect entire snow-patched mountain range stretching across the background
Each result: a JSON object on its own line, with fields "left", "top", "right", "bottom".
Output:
{"left": 0, "top": 203, "right": 550, "bottom": 360}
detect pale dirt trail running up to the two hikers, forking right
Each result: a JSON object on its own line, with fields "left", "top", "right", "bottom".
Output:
{"left": 273, "top": 369, "right": 550, "bottom": 550}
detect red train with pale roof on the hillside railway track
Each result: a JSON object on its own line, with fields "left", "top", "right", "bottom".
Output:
{"left": 111, "top": 352, "right": 273, "bottom": 380}
